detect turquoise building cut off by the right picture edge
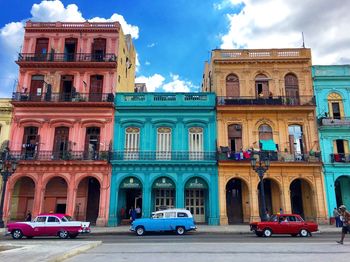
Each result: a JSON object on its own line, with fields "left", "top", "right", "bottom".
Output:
{"left": 312, "top": 65, "right": 350, "bottom": 216}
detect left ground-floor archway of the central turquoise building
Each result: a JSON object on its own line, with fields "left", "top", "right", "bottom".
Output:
{"left": 118, "top": 177, "right": 142, "bottom": 224}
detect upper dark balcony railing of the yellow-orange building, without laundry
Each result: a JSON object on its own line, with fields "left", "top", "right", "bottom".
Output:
{"left": 216, "top": 96, "right": 316, "bottom": 106}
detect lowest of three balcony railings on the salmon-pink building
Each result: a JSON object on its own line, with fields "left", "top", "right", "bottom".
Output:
{"left": 11, "top": 150, "right": 109, "bottom": 161}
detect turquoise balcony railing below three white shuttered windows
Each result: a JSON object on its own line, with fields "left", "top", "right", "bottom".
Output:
{"left": 110, "top": 151, "right": 216, "bottom": 161}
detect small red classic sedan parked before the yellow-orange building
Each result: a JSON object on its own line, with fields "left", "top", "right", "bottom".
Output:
{"left": 250, "top": 214, "right": 318, "bottom": 237}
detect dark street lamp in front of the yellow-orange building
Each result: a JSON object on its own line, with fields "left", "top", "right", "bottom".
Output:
{"left": 250, "top": 151, "right": 270, "bottom": 221}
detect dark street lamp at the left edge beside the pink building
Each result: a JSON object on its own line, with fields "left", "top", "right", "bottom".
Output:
{"left": 0, "top": 148, "right": 17, "bottom": 228}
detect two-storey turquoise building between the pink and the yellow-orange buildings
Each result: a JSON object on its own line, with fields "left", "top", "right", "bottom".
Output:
{"left": 109, "top": 93, "right": 219, "bottom": 226}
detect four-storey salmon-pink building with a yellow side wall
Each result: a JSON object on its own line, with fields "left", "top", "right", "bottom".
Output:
{"left": 4, "top": 21, "right": 135, "bottom": 225}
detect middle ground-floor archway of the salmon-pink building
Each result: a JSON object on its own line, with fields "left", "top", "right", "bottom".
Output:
{"left": 44, "top": 177, "right": 67, "bottom": 215}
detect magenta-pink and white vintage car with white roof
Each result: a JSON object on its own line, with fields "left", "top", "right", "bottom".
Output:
{"left": 6, "top": 214, "right": 90, "bottom": 239}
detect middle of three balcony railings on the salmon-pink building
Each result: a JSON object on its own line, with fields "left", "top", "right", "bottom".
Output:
{"left": 12, "top": 92, "right": 114, "bottom": 102}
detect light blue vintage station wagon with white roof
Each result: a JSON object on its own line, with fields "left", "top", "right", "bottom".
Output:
{"left": 130, "top": 209, "right": 197, "bottom": 236}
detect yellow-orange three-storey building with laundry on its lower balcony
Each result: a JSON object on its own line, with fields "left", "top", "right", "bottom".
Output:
{"left": 202, "top": 48, "right": 327, "bottom": 225}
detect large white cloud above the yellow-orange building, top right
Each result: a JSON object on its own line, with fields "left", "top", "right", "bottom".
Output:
{"left": 220, "top": 0, "right": 350, "bottom": 64}
